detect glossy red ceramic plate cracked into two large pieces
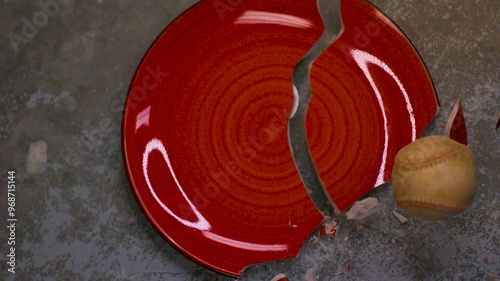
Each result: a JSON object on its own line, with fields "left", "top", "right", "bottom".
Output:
{"left": 123, "top": 0, "right": 437, "bottom": 276}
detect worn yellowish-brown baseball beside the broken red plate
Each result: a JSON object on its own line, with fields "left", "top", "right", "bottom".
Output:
{"left": 392, "top": 136, "right": 476, "bottom": 221}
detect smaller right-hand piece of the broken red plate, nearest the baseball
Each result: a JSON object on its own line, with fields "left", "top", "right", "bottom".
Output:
{"left": 307, "top": 0, "right": 438, "bottom": 210}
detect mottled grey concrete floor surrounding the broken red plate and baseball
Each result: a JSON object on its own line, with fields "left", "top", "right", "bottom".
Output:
{"left": 0, "top": 0, "right": 500, "bottom": 281}
